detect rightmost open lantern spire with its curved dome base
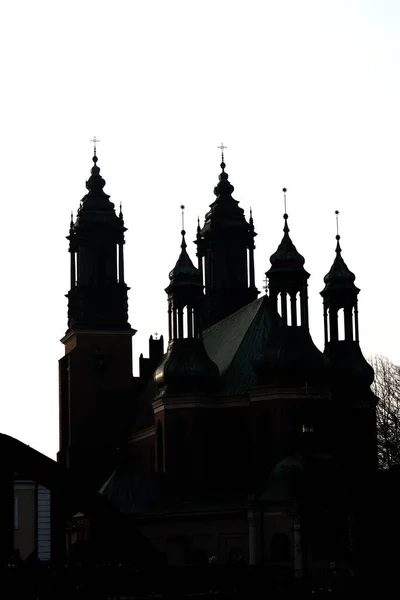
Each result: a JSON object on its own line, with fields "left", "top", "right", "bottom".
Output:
{"left": 321, "top": 211, "right": 374, "bottom": 386}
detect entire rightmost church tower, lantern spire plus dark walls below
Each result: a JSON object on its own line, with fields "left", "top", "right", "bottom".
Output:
{"left": 321, "top": 211, "right": 377, "bottom": 477}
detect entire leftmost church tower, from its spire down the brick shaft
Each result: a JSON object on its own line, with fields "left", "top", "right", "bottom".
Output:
{"left": 58, "top": 146, "right": 135, "bottom": 485}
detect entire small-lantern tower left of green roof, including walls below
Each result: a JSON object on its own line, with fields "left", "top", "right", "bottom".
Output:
{"left": 153, "top": 220, "right": 219, "bottom": 494}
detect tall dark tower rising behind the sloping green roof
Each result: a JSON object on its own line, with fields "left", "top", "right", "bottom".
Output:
{"left": 196, "top": 145, "right": 259, "bottom": 328}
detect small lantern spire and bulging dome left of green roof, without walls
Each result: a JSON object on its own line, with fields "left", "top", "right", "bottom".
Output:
{"left": 154, "top": 217, "right": 219, "bottom": 397}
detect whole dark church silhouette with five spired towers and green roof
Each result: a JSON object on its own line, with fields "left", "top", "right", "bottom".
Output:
{"left": 58, "top": 151, "right": 377, "bottom": 578}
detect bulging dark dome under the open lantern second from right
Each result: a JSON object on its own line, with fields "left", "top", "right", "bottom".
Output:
{"left": 253, "top": 326, "right": 330, "bottom": 387}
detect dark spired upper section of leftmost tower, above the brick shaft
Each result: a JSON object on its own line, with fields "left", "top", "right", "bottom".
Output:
{"left": 67, "top": 148, "right": 130, "bottom": 329}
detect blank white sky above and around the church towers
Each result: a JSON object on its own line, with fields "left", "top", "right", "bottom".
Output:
{"left": 0, "top": 0, "right": 400, "bottom": 457}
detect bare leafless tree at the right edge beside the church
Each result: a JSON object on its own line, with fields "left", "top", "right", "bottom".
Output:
{"left": 370, "top": 355, "right": 400, "bottom": 469}
